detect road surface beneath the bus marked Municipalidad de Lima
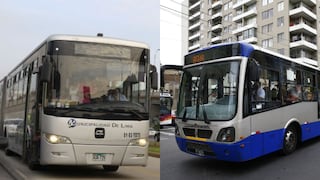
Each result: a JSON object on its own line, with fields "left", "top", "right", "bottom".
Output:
{"left": 0, "top": 150, "right": 160, "bottom": 180}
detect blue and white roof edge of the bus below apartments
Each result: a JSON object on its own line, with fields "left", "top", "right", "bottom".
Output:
{"left": 185, "top": 42, "right": 319, "bottom": 70}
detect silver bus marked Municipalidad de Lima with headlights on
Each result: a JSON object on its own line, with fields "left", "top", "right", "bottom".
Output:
{"left": 0, "top": 35, "right": 157, "bottom": 171}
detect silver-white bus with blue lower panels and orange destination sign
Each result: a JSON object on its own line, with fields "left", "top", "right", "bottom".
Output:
{"left": 175, "top": 42, "right": 320, "bottom": 162}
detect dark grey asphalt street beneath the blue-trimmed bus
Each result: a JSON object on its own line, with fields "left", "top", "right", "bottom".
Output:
{"left": 160, "top": 127, "right": 320, "bottom": 180}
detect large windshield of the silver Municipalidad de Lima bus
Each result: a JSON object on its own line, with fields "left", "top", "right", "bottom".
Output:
{"left": 43, "top": 41, "right": 148, "bottom": 120}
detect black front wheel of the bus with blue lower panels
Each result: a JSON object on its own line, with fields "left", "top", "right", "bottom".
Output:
{"left": 282, "top": 126, "right": 298, "bottom": 155}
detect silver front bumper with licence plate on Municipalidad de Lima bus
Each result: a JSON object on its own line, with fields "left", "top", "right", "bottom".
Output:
{"left": 40, "top": 141, "right": 148, "bottom": 166}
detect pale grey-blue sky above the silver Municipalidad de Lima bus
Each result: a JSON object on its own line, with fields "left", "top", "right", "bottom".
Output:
{"left": 0, "top": 0, "right": 160, "bottom": 79}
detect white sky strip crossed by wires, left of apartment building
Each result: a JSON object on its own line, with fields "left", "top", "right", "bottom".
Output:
{"left": 160, "top": 0, "right": 187, "bottom": 65}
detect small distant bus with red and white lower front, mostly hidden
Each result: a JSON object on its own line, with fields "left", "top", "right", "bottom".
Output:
{"left": 160, "top": 92, "right": 174, "bottom": 127}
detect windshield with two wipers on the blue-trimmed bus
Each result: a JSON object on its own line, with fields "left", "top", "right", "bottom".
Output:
{"left": 177, "top": 61, "right": 240, "bottom": 121}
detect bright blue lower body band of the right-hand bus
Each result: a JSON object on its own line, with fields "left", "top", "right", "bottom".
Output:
{"left": 176, "top": 122, "right": 320, "bottom": 162}
